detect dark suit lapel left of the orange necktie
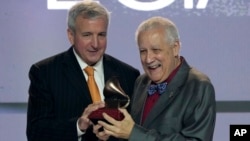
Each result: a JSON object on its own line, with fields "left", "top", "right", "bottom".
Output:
{"left": 62, "top": 48, "right": 92, "bottom": 102}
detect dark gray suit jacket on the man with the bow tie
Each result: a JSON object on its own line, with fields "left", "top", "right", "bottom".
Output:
{"left": 129, "top": 59, "right": 216, "bottom": 141}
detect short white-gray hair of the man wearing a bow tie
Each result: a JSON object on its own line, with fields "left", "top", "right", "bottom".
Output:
{"left": 135, "top": 16, "right": 180, "bottom": 45}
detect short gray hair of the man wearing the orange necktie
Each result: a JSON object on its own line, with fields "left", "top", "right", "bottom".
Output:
{"left": 68, "top": 0, "right": 110, "bottom": 32}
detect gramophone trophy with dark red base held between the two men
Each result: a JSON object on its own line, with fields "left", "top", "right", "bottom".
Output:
{"left": 89, "top": 77, "right": 130, "bottom": 124}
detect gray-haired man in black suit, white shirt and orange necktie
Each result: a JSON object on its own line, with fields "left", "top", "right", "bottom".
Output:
{"left": 26, "top": 0, "right": 139, "bottom": 141}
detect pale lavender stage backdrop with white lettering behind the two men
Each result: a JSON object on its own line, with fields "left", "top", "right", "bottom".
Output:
{"left": 0, "top": 0, "right": 250, "bottom": 141}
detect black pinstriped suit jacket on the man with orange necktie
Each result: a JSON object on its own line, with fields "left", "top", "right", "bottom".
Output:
{"left": 27, "top": 47, "right": 139, "bottom": 141}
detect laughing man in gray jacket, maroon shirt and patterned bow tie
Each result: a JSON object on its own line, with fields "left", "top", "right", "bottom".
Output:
{"left": 94, "top": 17, "right": 216, "bottom": 141}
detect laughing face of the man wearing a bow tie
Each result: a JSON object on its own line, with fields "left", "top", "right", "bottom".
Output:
{"left": 138, "top": 27, "right": 180, "bottom": 83}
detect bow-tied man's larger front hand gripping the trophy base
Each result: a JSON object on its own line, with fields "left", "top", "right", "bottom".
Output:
{"left": 98, "top": 108, "right": 135, "bottom": 139}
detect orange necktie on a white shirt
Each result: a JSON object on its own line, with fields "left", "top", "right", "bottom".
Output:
{"left": 84, "top": 66, "right": 101, "bottom": 103}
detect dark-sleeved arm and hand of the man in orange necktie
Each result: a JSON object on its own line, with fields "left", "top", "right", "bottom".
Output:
{"left": 27, "top": 65, "right": 104, "bottom": 141}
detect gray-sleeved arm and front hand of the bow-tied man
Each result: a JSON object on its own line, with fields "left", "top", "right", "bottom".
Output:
{"left": 96, "top": 80, "right": 215, "bottom": 141}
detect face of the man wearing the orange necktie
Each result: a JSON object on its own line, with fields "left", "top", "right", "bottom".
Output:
{"left": 68, "top": 16, "right": 108, "bottom": 65}
